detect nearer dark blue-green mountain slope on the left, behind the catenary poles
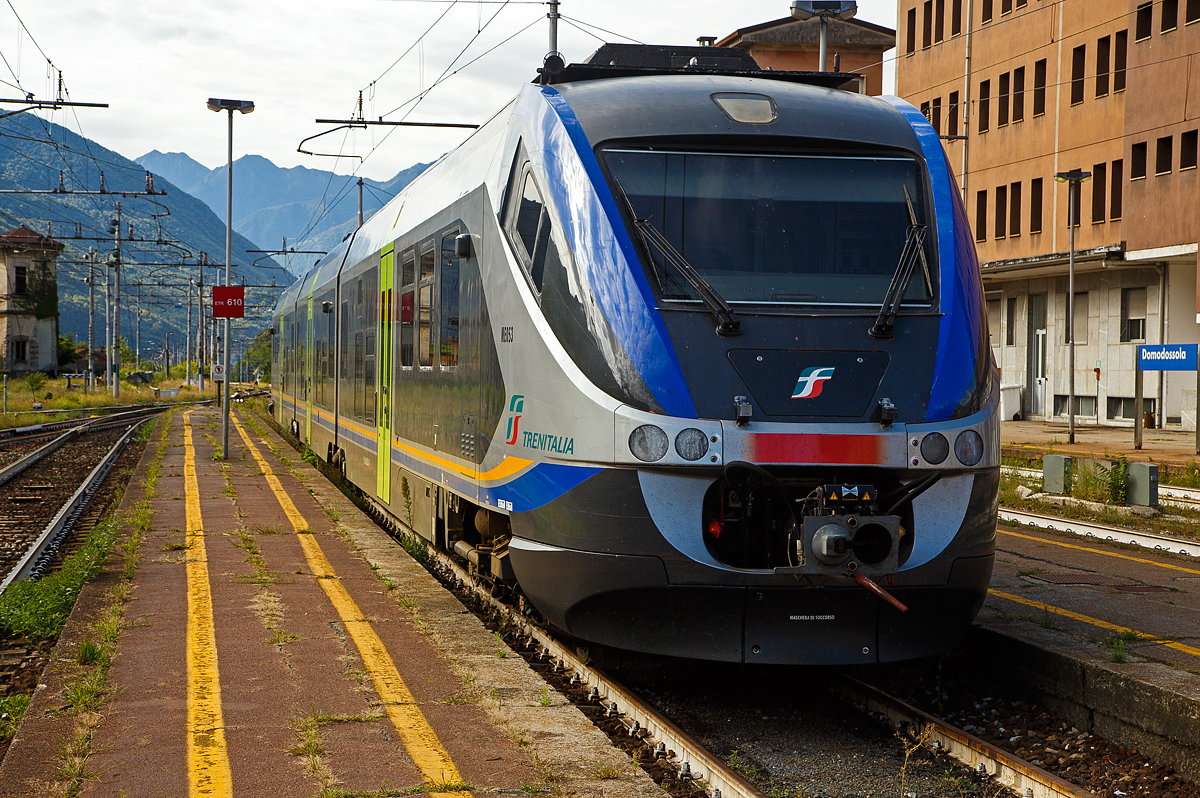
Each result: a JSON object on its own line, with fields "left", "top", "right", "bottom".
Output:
{"left": 0, "top": 114, "right": 293, "bottom": 357}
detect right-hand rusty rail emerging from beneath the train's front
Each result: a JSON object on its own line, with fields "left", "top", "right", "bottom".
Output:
{"left": 834, "top": 674, "right": 1094, "bottom": 798}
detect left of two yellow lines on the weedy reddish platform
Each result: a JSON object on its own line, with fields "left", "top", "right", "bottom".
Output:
{"left": 184, "top": 410, "right": 233, "bottom": 798}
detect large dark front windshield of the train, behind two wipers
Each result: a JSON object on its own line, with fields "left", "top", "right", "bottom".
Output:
{"left": 601, "top": 148, "right": 937, "bottom": 308}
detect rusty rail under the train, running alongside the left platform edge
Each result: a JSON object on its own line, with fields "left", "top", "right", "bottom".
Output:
{"left": 371, "top": 500, "right": 767, "bottom": 798}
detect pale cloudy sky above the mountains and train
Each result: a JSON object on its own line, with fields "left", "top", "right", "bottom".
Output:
{"left": 7, "top": 0, "right": 896, "bottom": 180}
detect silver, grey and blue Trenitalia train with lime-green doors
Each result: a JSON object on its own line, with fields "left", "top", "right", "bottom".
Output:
{"left": 271, "top": 44, "right": 1000, "bottom": 665}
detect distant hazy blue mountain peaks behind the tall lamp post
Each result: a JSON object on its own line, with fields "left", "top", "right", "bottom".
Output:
{"left": 137, "top": 150, "right": 430, "bottom": 255}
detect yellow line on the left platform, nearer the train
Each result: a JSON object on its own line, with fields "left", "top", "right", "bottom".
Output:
{"left": 233, "top": 418, "right": 470, "bottom": 798}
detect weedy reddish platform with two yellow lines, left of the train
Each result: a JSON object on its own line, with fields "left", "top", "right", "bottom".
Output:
{"left": 0, "top": 409, "right": 662, "bottom": 798}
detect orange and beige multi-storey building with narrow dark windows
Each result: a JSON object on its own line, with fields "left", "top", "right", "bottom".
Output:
{"left": 896, "top": 0, "right": 1200, "bottom": 428}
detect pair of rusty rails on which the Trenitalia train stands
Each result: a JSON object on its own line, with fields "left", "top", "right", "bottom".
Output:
{"left": 352, "top": 494, "right": 1090, "bottom": 798}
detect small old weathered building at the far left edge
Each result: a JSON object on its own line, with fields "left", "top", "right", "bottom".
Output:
{"left": 0, "top": 226, "right": 64, "bottom": 374}
